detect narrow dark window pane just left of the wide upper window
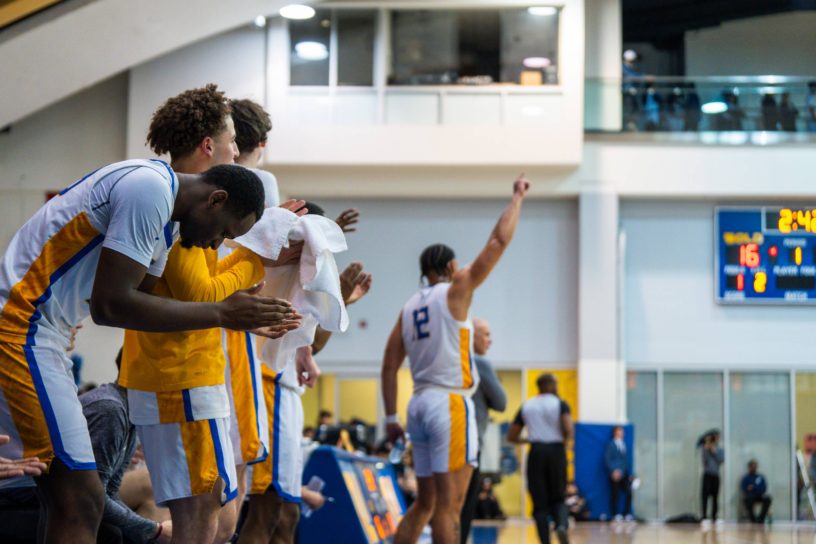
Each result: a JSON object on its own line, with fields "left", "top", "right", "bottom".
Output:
{"left": 336, "top": 10, "right": 377, "bottom": 86}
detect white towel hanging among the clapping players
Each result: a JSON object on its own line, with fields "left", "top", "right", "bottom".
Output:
{"left": 255, "top": 215, "right": 349, "bottom": 372}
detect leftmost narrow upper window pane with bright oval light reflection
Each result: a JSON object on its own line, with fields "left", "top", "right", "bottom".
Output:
{"left": 289, "top": 10, "right": 331, "bottom": 85}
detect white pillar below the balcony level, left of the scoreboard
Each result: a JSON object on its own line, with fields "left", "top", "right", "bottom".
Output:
{"left": 578, "top": 188, "right": 626, "bottom": 423}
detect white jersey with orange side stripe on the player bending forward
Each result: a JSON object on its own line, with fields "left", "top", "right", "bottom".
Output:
{"left": 0, "top": 160, "right": 178, "bottom": 346}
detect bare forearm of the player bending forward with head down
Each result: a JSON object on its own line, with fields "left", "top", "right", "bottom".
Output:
{"left": 91, "top": 289, "right": 222, "bottom": 332}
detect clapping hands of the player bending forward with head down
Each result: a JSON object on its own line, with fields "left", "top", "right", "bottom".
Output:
{"left": 219, "top": 282, "right": 301, "bottom": 331}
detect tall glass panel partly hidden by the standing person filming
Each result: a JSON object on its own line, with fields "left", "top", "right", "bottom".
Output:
{"left": 664, "top": 372, "right": 725, "bottom": 517}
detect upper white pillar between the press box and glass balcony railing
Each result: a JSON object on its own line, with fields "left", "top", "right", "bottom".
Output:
{"left": 584, "top": 0, "right": 623, "bottom": 132}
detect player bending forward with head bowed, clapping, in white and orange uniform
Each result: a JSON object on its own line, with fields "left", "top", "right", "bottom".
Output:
{"left": 0, "top": 160, "right": 291, "bottom": 542}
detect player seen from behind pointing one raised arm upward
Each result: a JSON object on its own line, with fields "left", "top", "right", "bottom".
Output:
{"left": 382, "top": 175, "right": 530, "bottom": 544}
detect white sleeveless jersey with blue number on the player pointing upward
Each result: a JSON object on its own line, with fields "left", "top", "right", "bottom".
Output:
{"left": 402, "top": 283, "right": 479, "bottom": 393}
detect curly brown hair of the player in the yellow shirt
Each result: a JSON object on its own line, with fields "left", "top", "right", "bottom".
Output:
{"left": 147, "top": 83, "right": 232, "bottom": 159}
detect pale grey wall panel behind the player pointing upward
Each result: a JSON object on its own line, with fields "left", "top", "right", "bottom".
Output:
{"left": 308, "top": 199, "right": 578, "bottom": 368}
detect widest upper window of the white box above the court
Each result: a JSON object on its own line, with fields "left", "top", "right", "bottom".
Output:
{"left": 390, "top": 7, "right": 558, "bottom": 85}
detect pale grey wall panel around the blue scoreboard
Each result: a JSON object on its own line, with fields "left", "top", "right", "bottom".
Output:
{"left": 621, "top": 200, "right": 816, "bottom": 369}
